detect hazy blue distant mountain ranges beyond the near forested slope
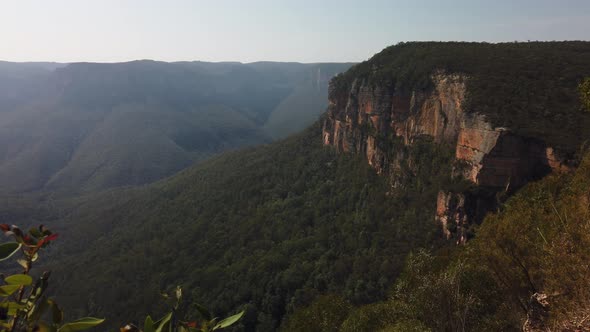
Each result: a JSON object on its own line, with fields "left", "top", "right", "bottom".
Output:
{"left": 0, "top": 60, "right": 350, "bottom": 193}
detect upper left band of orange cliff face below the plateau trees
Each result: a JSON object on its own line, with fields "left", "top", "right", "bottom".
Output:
{"left": 323, "top": 74, "right": 465, "bottom": 161}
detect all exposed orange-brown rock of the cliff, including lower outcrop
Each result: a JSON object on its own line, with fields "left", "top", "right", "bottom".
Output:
{"left": 322, "top": 72, "right": 568, "bottom": 242}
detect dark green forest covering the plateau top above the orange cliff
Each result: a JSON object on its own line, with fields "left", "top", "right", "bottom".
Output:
{"left": 333, "top": 41, "right": 590, "bottom": 152}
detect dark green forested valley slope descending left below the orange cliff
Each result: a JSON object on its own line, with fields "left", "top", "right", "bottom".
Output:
{"left": 45, "top": 124, "right": 452, "bottom": 331}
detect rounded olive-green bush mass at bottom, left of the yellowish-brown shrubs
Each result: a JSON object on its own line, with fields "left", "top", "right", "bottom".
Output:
{"left": 324, "top": 250, "right": 518, "bottom": 332}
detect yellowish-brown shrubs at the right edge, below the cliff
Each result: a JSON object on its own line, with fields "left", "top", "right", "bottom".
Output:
{"left": 469, "top": 155, "right": 590, "bottom": 330}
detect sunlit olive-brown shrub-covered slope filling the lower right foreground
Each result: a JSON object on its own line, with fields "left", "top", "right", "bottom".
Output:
{"left": 283, "top": 151, "right": 590, "bottom": 332}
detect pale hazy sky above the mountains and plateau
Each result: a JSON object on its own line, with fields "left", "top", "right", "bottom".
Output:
{"left": 0, "top": 0, "right": 590, "bottom": 62}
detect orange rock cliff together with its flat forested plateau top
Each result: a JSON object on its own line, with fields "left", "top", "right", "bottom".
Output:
{"left": 323, "top": 42, "right": 590, "bottom": 242}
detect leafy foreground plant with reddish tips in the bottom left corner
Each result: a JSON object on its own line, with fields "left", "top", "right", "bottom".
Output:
{"left": 0, "top": 224, "right": 104, "bottom": 332}
